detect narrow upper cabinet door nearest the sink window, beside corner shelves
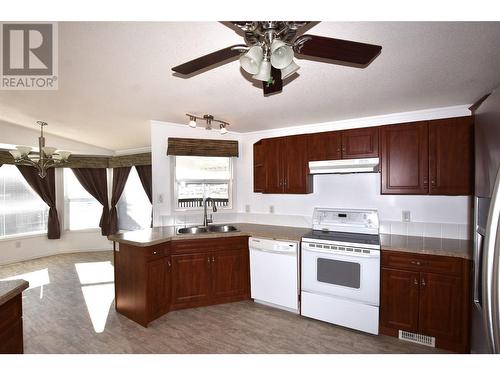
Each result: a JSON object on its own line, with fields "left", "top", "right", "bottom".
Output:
{"left": 262, "top": 137, "right": 285, "bottom": 194}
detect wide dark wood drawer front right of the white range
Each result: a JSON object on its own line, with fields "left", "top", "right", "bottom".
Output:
{"left": 381, "top": 251, "right": 464, "bottom": 276}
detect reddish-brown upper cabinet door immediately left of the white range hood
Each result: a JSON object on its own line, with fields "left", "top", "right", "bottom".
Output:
{"left": 283, "top": 135, "right": 312, "bottom": 194}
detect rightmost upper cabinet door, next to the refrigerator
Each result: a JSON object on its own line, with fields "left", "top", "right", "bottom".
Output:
{"left": 429, "top": 116, "right": 474, "bottom": 195}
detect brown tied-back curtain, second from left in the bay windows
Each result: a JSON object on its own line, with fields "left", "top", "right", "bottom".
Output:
{"left": 72, "top": 168, "right": 109, "bottom": 236}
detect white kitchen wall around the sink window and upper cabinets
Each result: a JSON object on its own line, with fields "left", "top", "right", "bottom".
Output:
{"left": 151, "top": 106, "right": 472, "bottom": 238}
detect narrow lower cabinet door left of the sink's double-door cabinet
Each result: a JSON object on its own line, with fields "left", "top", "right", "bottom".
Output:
{"left": 147, "top": 258, "right": 170, "bottom": 320}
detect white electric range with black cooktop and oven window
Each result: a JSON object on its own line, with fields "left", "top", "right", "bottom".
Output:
{"left": 301, "top": 208, "right": 380, "bottom": 334}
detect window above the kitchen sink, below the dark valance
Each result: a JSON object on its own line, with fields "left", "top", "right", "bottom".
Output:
{"left": 174, "top": 156, "right": 233, "bottom": 210}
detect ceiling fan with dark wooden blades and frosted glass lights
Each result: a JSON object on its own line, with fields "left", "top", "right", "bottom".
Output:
{"left": 172, "top": 21, "right": 382, "bottom": 96}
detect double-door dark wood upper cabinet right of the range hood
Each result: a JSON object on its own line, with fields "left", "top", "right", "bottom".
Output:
{"left": 380, "top": 116, "right": 474, "bottom": 195}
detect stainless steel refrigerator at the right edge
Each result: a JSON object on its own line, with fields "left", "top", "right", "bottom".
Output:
{"left": 471, "top": 90, "right": 500, "bottom": 353}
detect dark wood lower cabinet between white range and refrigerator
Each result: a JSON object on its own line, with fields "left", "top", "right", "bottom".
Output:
{"left": 380, "top": 251, "right": 471, "bottom": 353}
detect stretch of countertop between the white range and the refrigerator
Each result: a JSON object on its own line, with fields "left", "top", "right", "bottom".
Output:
{"left": 380, "top": 234, "right": 472, "bottom": 259}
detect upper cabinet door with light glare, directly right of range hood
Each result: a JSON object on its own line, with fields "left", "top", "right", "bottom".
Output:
{"left": 380, "top": 121, "right": 429, "bottom": 194}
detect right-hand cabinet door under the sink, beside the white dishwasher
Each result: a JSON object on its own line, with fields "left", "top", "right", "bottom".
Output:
{"left": 212, "top": 249, "right": 250, "bottom": 300}
